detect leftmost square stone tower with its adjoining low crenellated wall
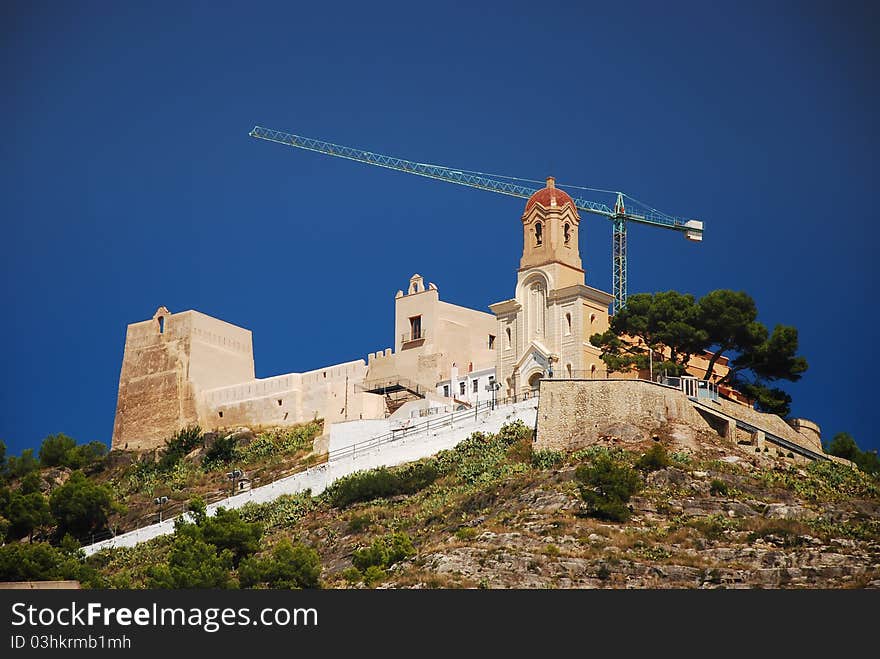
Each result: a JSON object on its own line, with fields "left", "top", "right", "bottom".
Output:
{"left": 112, "top": 307, "right": 385, "bottom": 450}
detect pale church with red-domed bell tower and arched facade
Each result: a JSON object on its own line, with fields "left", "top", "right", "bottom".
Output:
{"left": 489, "top": 177, "right": 612, "bottom": 396}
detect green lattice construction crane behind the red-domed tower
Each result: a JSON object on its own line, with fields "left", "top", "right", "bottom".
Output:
{"left": 250, "top": 126, "right": 703, "bottom": 313}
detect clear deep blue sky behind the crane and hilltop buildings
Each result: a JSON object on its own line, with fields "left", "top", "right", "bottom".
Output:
{"left": 0, "top": 2, "right": 880, "bottom": 453}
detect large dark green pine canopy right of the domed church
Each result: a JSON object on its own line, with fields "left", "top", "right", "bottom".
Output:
{"left": 590, "top": 289, "right": 807, "bottom": 416}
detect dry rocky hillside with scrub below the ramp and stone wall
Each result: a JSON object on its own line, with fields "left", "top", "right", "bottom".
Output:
{"left": 90, "top": 425, "right": 880, "bottom": 588}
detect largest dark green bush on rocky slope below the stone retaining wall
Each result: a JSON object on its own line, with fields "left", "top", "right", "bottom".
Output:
{"left": 575, "top": 454, "right": 642, "bottom": 522}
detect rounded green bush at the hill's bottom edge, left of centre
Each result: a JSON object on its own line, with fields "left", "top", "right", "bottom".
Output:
{"left": 238, "top": 539, "right": 321, "bottom": 589}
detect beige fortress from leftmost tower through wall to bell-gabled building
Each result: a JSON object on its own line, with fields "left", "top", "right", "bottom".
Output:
{"left": 112, "top": 275, "right": 496, "bottom": 450}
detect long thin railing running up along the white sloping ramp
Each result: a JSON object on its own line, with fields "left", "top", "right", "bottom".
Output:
{"left": 77, "top": 391, "right": 538, "bottom": 546}
